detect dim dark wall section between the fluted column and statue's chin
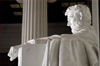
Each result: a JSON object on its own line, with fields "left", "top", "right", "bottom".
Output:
{"left": 48, "top": 22, "right": 72, "bottom": 36}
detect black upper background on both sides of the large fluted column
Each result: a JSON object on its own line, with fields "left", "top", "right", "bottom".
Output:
{"left": 0, "top": 0, "right": 91, "bottom": 24}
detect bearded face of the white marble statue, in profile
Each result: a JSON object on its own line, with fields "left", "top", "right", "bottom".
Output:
{"left": 67, "top": 10, "right": 84, "bottom": 29}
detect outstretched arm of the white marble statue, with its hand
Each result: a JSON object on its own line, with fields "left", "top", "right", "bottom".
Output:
{"left": 8, "top": 35, "right": 61, "bottom": 61}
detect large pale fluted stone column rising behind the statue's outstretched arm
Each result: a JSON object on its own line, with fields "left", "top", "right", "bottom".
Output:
{"left": 22, "top": 0, "right": 47, "bottom": 44}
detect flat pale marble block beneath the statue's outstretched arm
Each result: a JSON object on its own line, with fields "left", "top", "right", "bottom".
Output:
{"left": 19, "top": 44, "right": 46, "bottom": 66}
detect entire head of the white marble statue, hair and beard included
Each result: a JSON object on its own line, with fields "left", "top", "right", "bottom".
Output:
{"left": 65, "top": 4, "right": 91, "bottom": 33}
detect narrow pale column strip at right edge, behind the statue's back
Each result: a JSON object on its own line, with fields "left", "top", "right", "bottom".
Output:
{"left": 92, "top": 0, "right": 99, "bottom": 34}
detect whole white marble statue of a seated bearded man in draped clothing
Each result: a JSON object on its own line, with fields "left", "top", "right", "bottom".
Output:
{"left": 8, "top": 4, "right": 99, "bottom": 66}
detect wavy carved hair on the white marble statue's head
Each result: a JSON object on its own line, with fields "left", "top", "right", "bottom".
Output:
{"left": 65, "top": 4, "right": 91, "bottom": 24}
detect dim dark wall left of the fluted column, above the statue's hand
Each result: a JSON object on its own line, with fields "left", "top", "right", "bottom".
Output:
{"left": 0, "top": 24, "right": 21, "bottom": 53}
